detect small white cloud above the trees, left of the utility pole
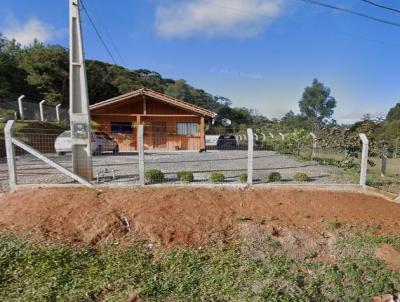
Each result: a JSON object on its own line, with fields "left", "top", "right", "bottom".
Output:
{"left": 0, "top": 15, "right": 65, "bottom": 46}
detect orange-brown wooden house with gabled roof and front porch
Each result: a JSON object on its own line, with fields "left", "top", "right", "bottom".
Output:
{"left": 90, "top": 88, "right": 217, "bottom": 151}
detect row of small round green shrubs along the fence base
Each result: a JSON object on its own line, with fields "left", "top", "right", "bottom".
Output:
{"left": 144, "top": 169, "right": 310, "bottom": 184}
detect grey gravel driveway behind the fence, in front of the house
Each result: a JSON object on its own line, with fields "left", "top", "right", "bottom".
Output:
{"left": 0, "top": 150, "right": 348, "bottom": 191}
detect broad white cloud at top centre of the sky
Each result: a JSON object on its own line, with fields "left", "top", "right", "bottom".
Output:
{"left": 156, "top": 0, "right": 284, "bottom": 38}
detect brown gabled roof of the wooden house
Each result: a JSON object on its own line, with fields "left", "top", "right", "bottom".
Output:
{"left": 89, "top": 88, "right": 217, "bottom": 118}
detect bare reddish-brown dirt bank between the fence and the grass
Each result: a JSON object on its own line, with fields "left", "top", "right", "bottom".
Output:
{"left": 0, "top": 187, "right": 400, "bottom": 248}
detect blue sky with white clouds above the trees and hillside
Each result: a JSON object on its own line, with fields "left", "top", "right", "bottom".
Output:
{"left": 0, "top": 0, "right": 400, "bottom": 123}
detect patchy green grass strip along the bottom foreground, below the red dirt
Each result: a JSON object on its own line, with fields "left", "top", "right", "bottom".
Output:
{"left": 0, "top": 235, "right": 400, "bottom": 301}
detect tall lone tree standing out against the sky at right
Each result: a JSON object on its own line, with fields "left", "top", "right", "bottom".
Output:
{"left": 299, "top": 79, "right": 336, "bottom": 131}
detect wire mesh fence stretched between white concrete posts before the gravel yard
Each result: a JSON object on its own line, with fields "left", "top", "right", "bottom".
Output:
{"left": 0, "top": 121, "right": 400, "bottom": 193}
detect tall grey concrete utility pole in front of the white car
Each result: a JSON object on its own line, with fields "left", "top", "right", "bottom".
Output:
{"left": 69, "top": 0, "right": 93, "bottom": 181}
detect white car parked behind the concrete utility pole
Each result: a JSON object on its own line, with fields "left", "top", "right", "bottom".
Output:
{"left": 54, "top": 131, "right": 119, "bottom": 155}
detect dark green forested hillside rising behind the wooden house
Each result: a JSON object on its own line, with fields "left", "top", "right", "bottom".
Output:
{"left": 0, "top": 33, "right": 266, "bottom": 129}
